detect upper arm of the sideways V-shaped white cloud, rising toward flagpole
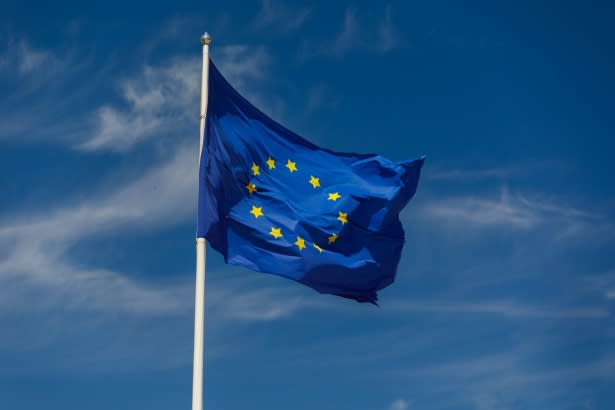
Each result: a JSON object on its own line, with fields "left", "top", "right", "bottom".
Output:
{"left": 0, "top": 142, "right": 197, "bottom": 247}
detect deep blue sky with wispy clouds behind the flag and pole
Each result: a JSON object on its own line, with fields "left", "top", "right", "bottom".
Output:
{"left": 0, "top": 1, "right": 615, "bottom": 410}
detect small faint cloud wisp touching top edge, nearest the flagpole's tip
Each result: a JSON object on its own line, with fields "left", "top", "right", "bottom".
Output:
{"left": 254, "top": 0, "right": 311, "bottom": 33}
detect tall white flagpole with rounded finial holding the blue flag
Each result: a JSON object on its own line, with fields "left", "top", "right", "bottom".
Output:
{"left": 192, "top": 33, "right": 212, "bottom": 410}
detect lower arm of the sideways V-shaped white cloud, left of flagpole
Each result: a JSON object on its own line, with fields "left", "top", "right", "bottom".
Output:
{"left": 0, "top": 256, "right": 191, "bottom": 316}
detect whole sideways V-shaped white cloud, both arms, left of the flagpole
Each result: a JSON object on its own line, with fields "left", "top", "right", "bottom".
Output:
{"left": 0, "top": 143, "right": 196, "bottom": 314}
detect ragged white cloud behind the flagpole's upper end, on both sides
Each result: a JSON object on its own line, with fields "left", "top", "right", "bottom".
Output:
{"left": 78, "top": 45, "right": 269, "bottom": 152}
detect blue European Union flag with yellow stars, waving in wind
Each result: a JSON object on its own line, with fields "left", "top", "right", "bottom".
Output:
{"left": 197, "top": 62, "right": 423, "bottom": 303}
